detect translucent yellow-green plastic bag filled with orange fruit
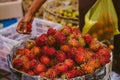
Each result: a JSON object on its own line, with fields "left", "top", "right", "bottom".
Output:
{"left": 82, "top": 0, "right": 119, "bottom": 41}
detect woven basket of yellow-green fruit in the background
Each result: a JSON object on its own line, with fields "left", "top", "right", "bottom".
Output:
{"left": 43, "top": 0, "right": 79, "bottom": 27}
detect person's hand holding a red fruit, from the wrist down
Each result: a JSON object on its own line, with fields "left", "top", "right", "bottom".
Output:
{"left": 16, "top": 14, "right": 33, "bottom": 34}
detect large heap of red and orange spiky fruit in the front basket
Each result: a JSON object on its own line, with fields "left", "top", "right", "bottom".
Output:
{"left": 10, "top": 26, "right": 111, "bottom": 80}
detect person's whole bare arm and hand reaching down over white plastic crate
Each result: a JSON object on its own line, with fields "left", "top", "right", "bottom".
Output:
{"left": 16, "top": 0, "right": 46, "bottom": 34}
